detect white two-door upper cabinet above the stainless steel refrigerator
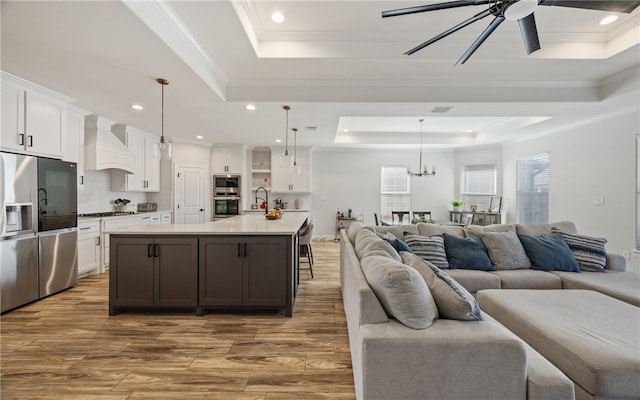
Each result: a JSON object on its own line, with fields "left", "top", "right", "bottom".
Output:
{"left": 0, "top": 72, "right": 73, "bottom": 158}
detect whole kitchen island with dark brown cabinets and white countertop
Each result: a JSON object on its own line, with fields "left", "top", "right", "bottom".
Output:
{"left": 107, "top": 213, "right": 309, "bottom": 317}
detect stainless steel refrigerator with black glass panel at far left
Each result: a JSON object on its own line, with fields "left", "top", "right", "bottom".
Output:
{"left": 0, "top": 152, "right": 78, "bottom": 312}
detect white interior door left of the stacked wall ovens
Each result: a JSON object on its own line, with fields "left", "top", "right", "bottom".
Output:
{"left": 174, "top": 165, "right": 208, "bottom": 224}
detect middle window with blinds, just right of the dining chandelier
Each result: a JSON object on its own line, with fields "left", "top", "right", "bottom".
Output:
{"left": 460, "top": 163, "right": 497, "bottom": 211}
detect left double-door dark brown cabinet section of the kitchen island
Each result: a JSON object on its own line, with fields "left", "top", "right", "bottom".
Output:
{"left": 109, "top": 235, "right": 198, "bottom": 315}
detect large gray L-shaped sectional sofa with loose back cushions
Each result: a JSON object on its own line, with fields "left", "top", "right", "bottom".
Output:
{"left": 340, "top": 221, "right": 640, "bottom": 400}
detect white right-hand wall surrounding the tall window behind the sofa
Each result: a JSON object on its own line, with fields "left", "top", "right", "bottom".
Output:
{"left": 503, "top": 109, "right": 640, "bottom": 268}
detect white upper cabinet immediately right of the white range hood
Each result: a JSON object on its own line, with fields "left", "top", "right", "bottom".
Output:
{"left": 111, "top": 124, "right": 160, "bottom": 192}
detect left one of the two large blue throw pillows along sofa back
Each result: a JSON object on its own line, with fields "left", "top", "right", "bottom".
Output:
{"left": 443, "top": 233, "right": 496, "bottom": 271}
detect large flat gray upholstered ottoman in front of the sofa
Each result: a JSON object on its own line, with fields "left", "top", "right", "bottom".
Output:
{"left": 477, "top": 289, "right": 640, "bottom": 399}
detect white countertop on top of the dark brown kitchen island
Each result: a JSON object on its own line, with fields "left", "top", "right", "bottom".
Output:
{"left": 106, "top": 212, "right": 309, "bottom": 235}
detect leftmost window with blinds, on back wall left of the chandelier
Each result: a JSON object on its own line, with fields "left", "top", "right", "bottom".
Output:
{"left": 380, "top": 166, "right": 411, "bottom": 219}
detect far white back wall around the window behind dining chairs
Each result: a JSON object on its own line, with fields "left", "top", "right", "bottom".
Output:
{"left": 311, "top": 150, "right": 455, "bottom": 238}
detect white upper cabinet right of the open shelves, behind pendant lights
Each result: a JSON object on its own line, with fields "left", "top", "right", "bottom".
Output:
{"left": 271, "top": 148, "right": 311, "bottom": 193}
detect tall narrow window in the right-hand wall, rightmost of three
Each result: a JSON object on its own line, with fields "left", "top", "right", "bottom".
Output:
{"left": 516, "top": 153, "right": 549, "bottom": 224}
